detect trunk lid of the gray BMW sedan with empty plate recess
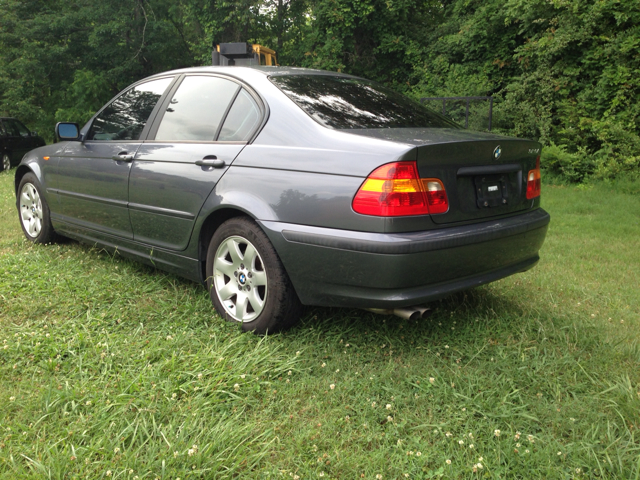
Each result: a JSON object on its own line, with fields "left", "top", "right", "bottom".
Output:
{"left": 344, "top": 128, "right": 540, "bottom": 224}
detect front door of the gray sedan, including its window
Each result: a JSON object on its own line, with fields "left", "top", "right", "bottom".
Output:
{"left": 55, "top": 76, "right": 175, "bottom": 238}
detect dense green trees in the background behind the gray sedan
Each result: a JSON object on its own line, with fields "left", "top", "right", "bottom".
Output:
{"left": 0, "top": 0, "right": 640, "bottom": 181}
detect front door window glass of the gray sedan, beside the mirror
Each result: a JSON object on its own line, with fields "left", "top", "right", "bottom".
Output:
{"left": 87, "top": 78, "right": 173, "bottom": 140}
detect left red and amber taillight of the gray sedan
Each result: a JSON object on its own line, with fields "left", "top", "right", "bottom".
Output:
{"left": 353, "top": 162, "right": 449, "bottom": 217}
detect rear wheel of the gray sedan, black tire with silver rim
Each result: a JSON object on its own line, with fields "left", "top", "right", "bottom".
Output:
{"left": 206, "top": 217, "right": 302, "bottom": 334}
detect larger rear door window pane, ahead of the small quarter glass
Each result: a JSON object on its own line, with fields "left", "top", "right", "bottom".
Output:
{"left": 155, "top": 76, "right": 240, "bottom": 142}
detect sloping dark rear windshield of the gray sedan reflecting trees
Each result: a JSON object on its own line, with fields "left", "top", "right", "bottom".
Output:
{"left": 269, "top": 75, "right": 461, "bottom": 129}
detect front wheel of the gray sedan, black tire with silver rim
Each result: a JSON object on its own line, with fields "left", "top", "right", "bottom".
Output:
{"left": 16, "top": 172, "right": 58, "bottom": 243}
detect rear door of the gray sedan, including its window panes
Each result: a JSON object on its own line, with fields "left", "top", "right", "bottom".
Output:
{"left": 129, "top": 75, "right": 264, "bottom": 250}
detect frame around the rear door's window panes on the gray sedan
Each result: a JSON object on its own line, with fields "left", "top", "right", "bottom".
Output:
{"left": 144, "top": 72, "right": 269, "bottom": 145}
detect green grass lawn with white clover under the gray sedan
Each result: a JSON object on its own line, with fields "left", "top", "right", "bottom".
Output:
{"left": 0, "top": 171, "right": 640, "bottom": 480}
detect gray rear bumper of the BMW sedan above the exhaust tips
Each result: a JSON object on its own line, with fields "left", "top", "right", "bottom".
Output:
{"left": 261, "top": 209, "right": 550, "bottom": 308}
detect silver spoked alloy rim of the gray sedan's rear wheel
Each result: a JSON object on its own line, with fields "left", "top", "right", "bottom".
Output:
{"left": 213, "top": 235, "right": 267, "bottom": 322}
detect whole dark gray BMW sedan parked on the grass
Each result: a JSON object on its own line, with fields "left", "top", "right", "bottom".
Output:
{"left": 15, "top": 67, "right": 549, "bottom": 332}
